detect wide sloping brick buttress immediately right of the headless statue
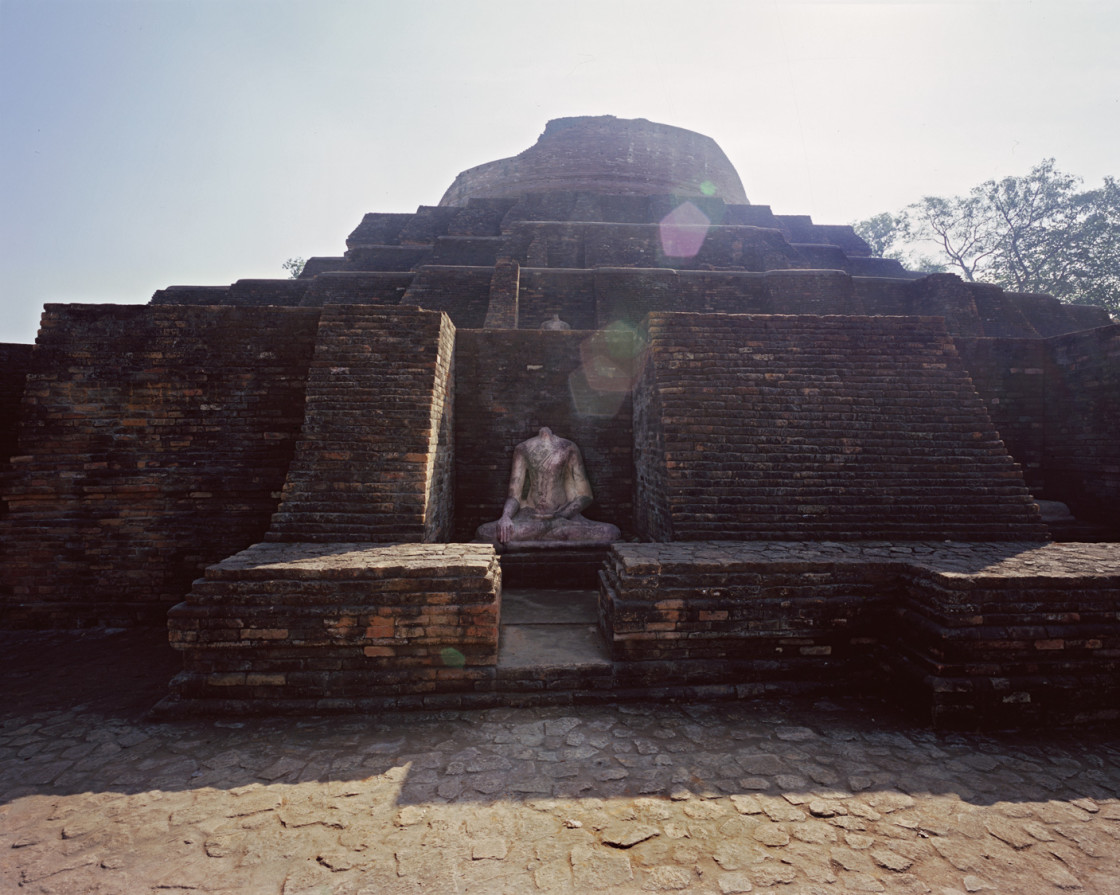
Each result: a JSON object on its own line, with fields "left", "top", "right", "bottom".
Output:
{"left": 635, "top": 314, "right": 1047, "bottom": 541}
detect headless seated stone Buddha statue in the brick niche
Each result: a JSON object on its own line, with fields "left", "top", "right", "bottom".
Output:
{"left": 477, "top": 427, "right": 620, "bottom": 546}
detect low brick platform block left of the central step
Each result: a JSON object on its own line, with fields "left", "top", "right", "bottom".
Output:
{"left": 168, "top": 543, "right": 502, "bottom": 711}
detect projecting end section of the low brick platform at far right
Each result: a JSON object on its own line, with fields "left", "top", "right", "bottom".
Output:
{"left": 890, "top": 543, "right": 1120, "bottom": 727}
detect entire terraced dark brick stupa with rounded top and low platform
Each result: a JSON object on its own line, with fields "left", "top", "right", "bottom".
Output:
{"left": 0, "top": 116, "right": 1120, "bottom": 725}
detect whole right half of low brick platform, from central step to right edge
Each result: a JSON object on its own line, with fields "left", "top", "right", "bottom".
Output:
{"left": 600, "top": 541, "right": 1120, "bottom": 727}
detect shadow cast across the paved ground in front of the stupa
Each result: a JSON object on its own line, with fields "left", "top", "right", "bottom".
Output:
{"left": 0, "top": 630, "right": 1120, "bottom": 804}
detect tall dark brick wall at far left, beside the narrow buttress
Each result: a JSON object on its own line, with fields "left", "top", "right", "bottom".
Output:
{"left": 0, "top": 305, "right": 318, "bottom": 626}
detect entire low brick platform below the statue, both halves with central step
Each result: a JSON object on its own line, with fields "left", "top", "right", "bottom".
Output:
{"left": 164, "top": 541, "right": 1120, "bottom": 727}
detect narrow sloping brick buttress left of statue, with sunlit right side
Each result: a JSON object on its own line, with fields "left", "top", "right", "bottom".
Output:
{"left": 267, "top": 305, "right": 455, "bottom": 542}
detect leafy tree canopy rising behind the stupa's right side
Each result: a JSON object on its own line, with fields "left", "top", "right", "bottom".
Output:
{"left": 855, "top": 159, "right": 1120, "bottom": 313}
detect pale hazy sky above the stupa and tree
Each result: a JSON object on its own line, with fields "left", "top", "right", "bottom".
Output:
{"left": 0, "top": 0, "right": 1120, "bottom": 342}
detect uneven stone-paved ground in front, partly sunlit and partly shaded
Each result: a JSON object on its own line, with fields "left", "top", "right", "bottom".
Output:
{"left": 0, "top": 631, "right": 1120, "bottom": 895}
